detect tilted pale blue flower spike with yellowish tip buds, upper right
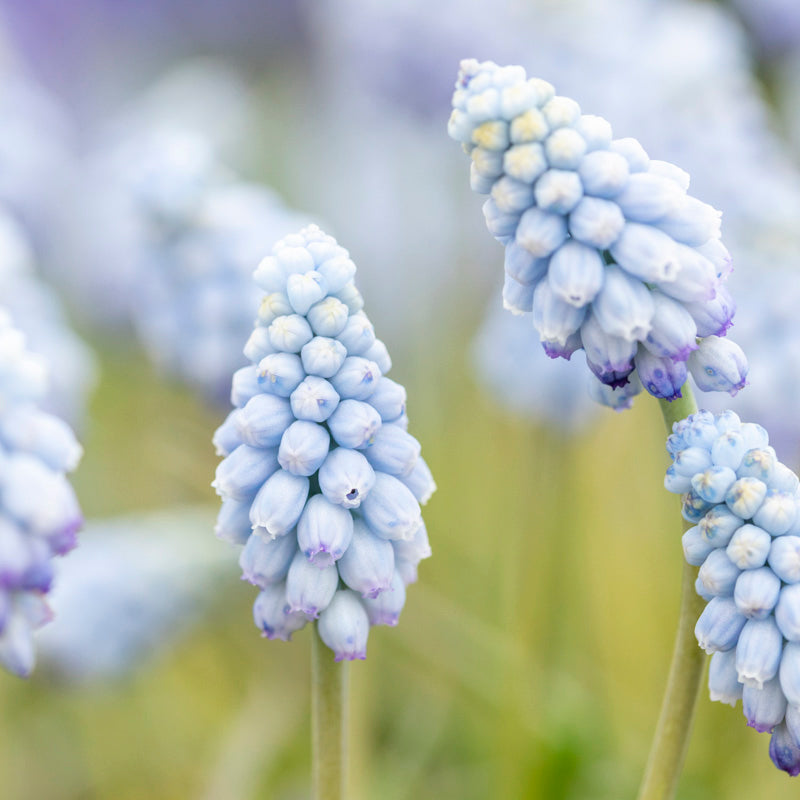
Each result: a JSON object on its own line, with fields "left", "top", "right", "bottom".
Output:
{"left": 448, "top": 59, "right": 747, "bottom": 407}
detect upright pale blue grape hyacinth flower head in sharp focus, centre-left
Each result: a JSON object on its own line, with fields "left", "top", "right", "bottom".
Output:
{"left": 213, "top": 225, "right": 435, "bottom": 661}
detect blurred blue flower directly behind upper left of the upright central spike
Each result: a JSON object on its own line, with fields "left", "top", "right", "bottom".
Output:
{"left": 133, "top": 171, "right": 310, "bottom": 403}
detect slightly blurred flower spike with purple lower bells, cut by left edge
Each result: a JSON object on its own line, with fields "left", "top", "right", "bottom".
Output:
{"left": 0, "top": 310, "right": 83, "bottom": 677}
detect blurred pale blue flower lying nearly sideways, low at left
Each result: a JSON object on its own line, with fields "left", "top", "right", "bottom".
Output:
{"left": 37, "top": 507, "right": 227, "bottom": 683}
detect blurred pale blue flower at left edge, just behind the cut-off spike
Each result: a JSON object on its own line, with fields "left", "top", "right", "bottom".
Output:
{"left": 0, "top": 212, "right": 97, "bottom": 425}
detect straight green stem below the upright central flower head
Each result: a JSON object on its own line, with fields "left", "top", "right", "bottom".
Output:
{"left": 311, "top": 625, "right": 349, "bottom": 800}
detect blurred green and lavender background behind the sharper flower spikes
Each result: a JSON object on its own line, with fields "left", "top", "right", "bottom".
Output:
{"left": 0, "top": 0, "right": 800, "bottom": 800}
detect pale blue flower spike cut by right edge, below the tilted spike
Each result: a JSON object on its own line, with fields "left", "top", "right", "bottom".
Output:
{"left": 665, "top": 411, "right": 800, "bottom": 775}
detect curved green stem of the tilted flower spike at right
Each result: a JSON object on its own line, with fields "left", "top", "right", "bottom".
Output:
{"left": 639, "top": 385, "right": 706, "bottom": 800}
